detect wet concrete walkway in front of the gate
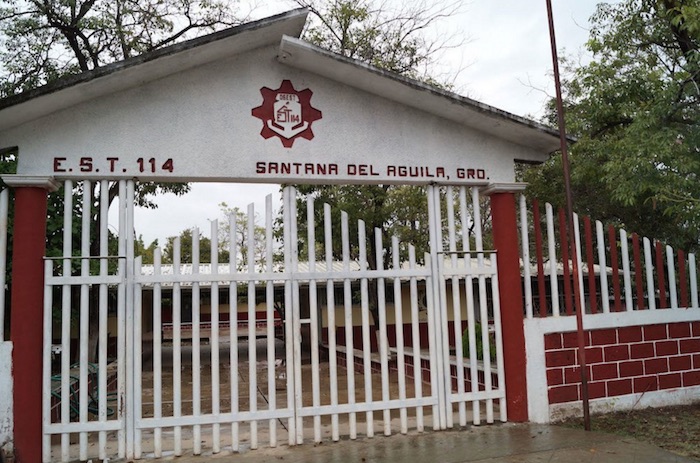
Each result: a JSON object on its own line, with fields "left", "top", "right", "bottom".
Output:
{"left": 130, "top": 424, "right": 696, "bottom": 463}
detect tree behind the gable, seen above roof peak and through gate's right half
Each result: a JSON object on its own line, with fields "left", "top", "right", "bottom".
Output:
{"left": 295, "top": 0, "right": 463, "bottom": 338}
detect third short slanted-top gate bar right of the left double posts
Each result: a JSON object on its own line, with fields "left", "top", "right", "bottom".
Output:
{"left": 192, "top": 227, "right": 202, "bottom": 455}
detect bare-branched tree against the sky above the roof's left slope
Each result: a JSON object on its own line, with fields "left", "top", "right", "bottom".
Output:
{"left": 0, "top": 0, "right": 240, "bottom": 96}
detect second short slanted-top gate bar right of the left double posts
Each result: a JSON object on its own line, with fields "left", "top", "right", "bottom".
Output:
{"left": 173, "top": 236, "right": 182, "bottom": 456}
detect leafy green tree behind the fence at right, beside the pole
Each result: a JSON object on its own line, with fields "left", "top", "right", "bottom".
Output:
{"left": 524, "top": 0, "right": 700, "bottom": 254}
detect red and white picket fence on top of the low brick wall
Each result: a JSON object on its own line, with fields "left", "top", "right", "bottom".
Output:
{"left": 520, "top": 196, "right": 698, "bottom": 318}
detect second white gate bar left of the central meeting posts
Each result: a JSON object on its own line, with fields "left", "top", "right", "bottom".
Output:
{"left": 246, "top": 203, "right": 258, "bottom": 449}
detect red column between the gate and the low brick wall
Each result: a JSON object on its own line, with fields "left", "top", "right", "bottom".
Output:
{"left": 486, "top": 183, "right": 528, "bottom": 422}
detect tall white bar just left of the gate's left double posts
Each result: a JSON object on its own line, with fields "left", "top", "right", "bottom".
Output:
{"left": 97, "top": 180, "right": 109, "bottom": 460}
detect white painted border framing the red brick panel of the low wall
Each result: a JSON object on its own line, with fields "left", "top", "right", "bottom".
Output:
{"left": 524, "top": 309, "right": 700, "bottom": 423}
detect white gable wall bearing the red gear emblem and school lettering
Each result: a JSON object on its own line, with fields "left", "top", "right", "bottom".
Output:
{"left": 0, "top": 47, "right": 542, "bottom": 184}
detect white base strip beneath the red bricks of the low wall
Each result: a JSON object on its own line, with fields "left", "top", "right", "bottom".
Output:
{"left": 549, "top": 386, "right": 700, "bottom": 422}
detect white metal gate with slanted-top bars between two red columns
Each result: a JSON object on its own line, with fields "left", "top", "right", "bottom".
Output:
{"left": 44, "top": 181, "right": 505, "bottom": 461}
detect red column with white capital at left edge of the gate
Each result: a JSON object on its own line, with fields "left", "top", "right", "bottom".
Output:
{"left": 3, "top": 176, "right": 55, "bottom": 463}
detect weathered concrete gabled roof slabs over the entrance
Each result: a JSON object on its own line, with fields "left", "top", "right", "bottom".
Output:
{"left": 0, "top": 9, "right": 559, "bottom": 154}
